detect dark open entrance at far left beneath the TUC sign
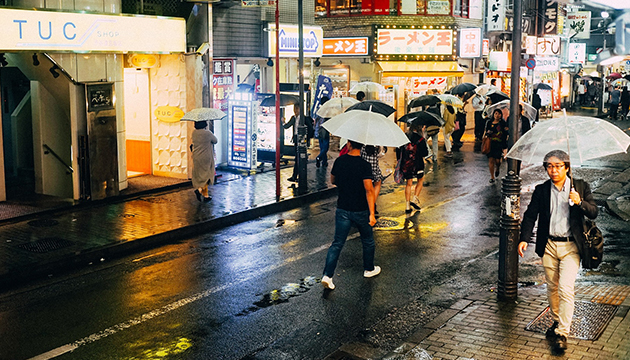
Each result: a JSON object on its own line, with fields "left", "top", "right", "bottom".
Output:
{"left": 0, "top": 67, "right": 35, "bottom": 200}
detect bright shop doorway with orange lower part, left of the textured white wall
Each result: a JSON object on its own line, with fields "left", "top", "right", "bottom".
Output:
{"left": 124, "top": 68, "right": 152, "bottom": 178}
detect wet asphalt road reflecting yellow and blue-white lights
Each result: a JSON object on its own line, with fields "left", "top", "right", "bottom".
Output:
{"left": 0, "top": 145, "right": 630, "bottom": 359}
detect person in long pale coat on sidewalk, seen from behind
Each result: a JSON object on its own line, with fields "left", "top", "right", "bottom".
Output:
{"left": 190, "top": 121, "right": 218, "bottom": 202}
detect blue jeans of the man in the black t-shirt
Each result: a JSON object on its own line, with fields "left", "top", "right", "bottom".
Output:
{"left": 324, "top": 209, "right": 374, "bottom": 277}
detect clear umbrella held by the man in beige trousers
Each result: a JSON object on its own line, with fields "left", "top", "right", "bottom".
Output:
{"left": 507, "top": 116, "right": 630, "bottom": 165}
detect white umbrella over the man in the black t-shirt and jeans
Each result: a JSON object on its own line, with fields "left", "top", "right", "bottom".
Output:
{"left": 323, "top": 110, "right": 409, "bottom": 147}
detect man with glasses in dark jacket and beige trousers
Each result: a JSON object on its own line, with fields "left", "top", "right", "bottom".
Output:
{"left": 518, "top": 150, "right": 598, "bottom": 351}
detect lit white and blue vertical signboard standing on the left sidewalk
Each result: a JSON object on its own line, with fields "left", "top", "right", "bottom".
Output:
{"left": 228, "top": 100, "right": 257, "bottom": 169}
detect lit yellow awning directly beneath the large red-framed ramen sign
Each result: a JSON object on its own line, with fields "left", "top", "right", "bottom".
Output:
{"left": 378, "top": 61, "right": 464, "bottom": 77}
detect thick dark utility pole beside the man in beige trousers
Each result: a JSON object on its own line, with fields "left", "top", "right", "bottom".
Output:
{"left": 497, "top": 0, "right": 523, "bottom": 300}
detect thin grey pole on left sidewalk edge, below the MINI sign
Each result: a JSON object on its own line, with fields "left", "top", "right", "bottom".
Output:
{"left": 295, "top": 0, "right": 308, "bottom": 195}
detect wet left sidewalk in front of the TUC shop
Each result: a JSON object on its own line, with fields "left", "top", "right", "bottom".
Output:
{"left": 0, "top": 154, "right": 336, "bottom": 289}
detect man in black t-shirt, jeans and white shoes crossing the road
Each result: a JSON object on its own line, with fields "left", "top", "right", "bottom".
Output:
{"left": 322, "top": 140, "right": 381, "bottom": 290}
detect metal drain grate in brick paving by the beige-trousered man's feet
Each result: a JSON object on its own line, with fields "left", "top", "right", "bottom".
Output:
{"left": 525, "top": 301, "right": 617, "bottom": 340}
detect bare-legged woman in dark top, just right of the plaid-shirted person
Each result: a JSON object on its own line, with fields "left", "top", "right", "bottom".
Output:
{"left": 396, "top": 127, "right": 429, "bottom": 214}
